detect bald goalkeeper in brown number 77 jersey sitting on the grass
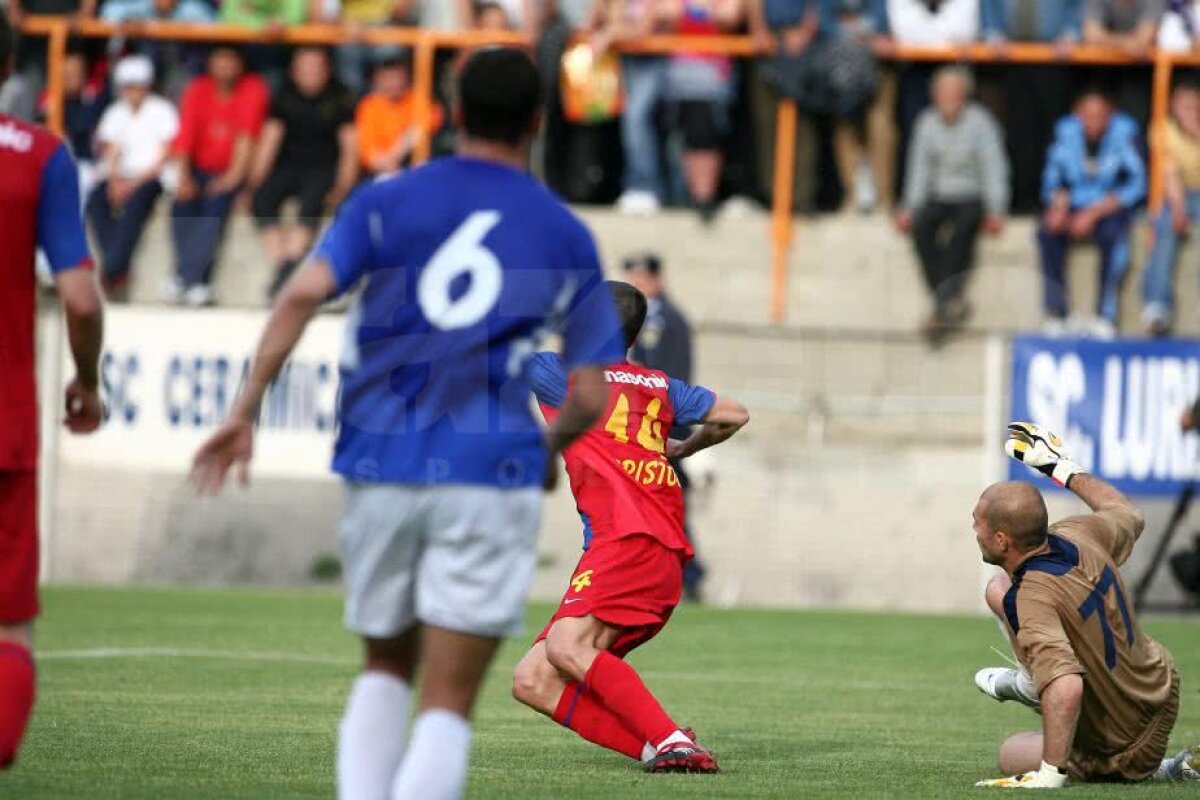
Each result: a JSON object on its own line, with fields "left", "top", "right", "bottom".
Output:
{"left": 973, "top": 422, "right": 1200, "bottom": 788}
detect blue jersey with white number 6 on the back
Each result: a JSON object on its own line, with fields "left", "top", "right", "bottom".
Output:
{"left": 314, "top": 157, "right": 624, "bottom": 488}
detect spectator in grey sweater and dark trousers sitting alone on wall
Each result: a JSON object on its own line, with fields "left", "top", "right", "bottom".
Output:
{"left": 896, "top": 67, "right": 1008, "bottom": 345}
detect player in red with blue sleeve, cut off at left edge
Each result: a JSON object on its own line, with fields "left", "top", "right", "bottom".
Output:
{"left": 0, "top": 8, "right": 103, "bottom": 769}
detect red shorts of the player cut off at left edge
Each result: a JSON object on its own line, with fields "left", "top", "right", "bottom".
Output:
{"left": 0, "top": 470, "right": 37, "bottom": 625}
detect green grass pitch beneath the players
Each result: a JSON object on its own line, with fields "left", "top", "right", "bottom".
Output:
{"left": 0, "top": 588, "right": 1200, "bottom": 800}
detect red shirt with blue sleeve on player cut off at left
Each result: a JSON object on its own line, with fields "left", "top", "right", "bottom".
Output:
{"left": 0, "top": 114, "right": 91, "bottom": 470}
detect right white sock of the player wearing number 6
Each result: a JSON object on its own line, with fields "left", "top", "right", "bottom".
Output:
{"left": 391, "top": 709, "right": 470, "bottom": 800}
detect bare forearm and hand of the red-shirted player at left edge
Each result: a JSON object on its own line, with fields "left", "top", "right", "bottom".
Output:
{"left": 54, "top": 267, "right": 104, "bottom": 433}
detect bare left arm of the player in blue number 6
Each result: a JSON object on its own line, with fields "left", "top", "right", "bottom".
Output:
{"left": 191, "top": 259, "right": 336, "bottom": 494}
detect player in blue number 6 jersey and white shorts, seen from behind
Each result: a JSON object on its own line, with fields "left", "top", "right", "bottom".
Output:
{"left": 192, "top": 49, "right": 624, "bottom": 800}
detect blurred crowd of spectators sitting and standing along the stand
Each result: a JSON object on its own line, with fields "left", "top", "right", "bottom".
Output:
{"left": 0, "top": 0, "right": 1200, "bottom": 344}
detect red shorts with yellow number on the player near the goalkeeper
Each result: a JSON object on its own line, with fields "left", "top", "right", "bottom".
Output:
{"left": 534, "top": 535, "right": 685, "bottom": 657}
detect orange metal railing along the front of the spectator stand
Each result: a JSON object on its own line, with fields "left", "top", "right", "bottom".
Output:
{"left": 14, "top": 16, "right": 1200, "bottom": 323}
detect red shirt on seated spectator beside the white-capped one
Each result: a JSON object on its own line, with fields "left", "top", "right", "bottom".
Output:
{"left": 172, "top": 76, "right": 270, "bottom": 173}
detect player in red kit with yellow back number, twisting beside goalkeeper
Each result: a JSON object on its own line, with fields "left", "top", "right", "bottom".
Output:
{"left": 512, "top": 281, "right": 750, "bottom": 772}
